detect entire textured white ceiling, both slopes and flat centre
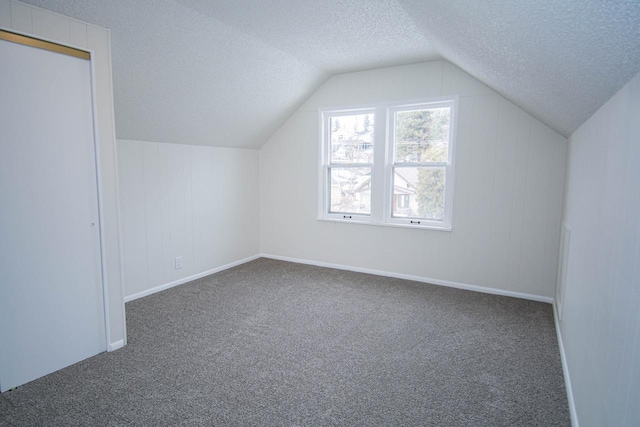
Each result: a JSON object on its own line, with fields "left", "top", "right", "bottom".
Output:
{"left": 20, "top": 0, "right": 640, "bottom": 148}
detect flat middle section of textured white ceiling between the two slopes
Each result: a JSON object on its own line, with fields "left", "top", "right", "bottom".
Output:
{"left": 177, "top": 0, "right": 439, "bottom": 74}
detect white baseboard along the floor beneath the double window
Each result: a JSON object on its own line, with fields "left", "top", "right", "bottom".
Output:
{"left": 260, "top": 253, "right": 553, "bottom": 304}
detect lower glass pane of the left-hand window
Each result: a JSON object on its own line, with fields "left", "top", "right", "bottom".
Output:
{"left": 329, "top": 168, "right": 371, "bottom": 215}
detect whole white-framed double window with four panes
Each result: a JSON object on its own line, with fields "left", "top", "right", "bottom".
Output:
{"left": 319, "top": 98, "right": 457, "bottom": 230}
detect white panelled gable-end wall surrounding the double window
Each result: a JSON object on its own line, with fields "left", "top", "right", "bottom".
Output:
{"left": 260, "top": 61, "right": 566, "bottom": 301}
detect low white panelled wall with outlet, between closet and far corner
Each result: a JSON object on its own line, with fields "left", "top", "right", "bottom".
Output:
{"left": 118, "top": 140, "right": 259, "bottom": 300}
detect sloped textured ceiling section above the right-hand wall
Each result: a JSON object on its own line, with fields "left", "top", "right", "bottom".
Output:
{"left": 400, "top": 0, "right": 640, "bottom": 136}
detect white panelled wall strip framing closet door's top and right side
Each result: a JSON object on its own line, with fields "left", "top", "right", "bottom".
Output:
{"left": 0, "top": 0, "right": 126, "bottom": 349}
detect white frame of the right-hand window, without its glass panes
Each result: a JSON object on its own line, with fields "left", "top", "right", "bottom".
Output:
{"left": 384, "top": 97, "right": 458, "bottom": 231}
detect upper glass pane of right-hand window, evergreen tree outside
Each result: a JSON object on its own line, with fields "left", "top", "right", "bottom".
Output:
{"left": 394, "top": 107, "right": 451, "bottom": 163}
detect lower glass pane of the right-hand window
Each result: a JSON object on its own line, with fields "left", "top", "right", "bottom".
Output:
{"left": 392, "top": 167, "right": 446, "bottom": 221}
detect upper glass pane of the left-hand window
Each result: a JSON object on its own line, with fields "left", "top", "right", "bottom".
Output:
{"left": 329, "top": 113, "right": 373, "bottom": 163}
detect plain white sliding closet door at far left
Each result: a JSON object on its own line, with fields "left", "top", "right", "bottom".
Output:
{"left": 0, "top": 35, "right": 106, "bottom": 391}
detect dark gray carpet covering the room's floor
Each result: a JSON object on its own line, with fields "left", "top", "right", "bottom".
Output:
{"left": 0, "top": 259, "right": 570, "bottom": 426}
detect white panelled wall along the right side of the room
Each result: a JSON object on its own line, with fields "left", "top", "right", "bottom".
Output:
{"left": 560, "top": 74, "right": 640, "bottom": 427}
